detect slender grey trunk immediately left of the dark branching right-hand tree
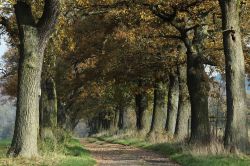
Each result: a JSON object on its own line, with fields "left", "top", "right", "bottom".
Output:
{"left": 175, "top": 64, "right": 191, "bottom": 141}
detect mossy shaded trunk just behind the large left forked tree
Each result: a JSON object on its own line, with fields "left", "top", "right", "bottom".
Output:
{"left": 39, "top": 46, "right": 57, "bottom": 139}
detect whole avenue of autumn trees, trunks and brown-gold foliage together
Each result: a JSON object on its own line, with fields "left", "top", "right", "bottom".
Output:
{"left": 0, "top": 0, "right": 250, "bottom": 157}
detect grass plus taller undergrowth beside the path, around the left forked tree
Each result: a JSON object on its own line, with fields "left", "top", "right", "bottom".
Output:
{"left": 0, "top": 131, "right": 95, "bottom": 166}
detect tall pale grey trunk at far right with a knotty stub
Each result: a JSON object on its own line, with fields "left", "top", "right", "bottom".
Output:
{"left": 220, "top": 0, "right": 248, "bottom": 151}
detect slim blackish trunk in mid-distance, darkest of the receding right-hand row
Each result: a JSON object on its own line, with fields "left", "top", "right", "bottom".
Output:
{"left": 135, "top": 81, "right": 148, "bottom": 130}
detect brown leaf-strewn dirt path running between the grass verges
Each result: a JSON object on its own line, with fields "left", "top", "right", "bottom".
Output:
{"left": 82, "top": 139, "right": 178, "bottom": 166}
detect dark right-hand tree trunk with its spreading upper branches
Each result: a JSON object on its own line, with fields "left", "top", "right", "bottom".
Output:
{"left": 150, "top": 5, "right": 211, "bottom": 145}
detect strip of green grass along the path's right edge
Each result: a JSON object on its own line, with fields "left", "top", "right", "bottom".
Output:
{"left": 96, "top": 136, "right": 250, "bottom": 166}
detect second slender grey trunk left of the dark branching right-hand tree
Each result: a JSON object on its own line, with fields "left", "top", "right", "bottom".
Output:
{"left": 166, "top": 71, "right": 179, "bottom": 135}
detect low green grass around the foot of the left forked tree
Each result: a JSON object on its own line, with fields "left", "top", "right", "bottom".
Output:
{"left": 0, "top": 139, "right": 96, "bottom": 166}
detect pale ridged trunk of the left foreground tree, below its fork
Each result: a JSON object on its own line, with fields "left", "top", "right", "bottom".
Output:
{"left": 8, "top": 25, "right": 43, "bottom": 157}
